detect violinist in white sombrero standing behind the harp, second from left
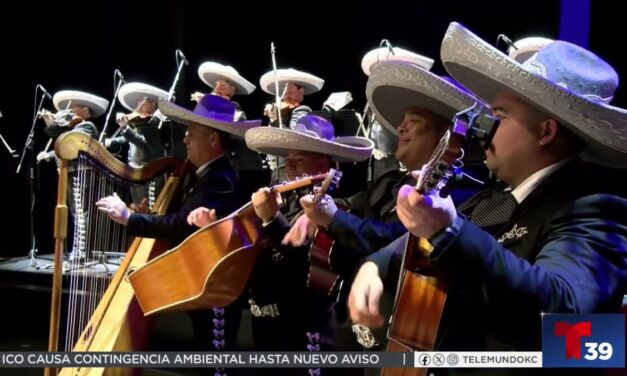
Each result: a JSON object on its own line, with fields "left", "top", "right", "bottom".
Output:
{"left": 105, "top": 82, "right": 168, "bottom": 203}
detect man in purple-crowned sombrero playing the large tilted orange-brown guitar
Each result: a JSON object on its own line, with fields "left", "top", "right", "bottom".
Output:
{"left": 223, "top": 115, "right": 373, "bottom": 362}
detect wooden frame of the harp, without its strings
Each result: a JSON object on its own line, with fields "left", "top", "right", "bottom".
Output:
{"left": 45, "top": 132, "right": 185, "bottom": 375}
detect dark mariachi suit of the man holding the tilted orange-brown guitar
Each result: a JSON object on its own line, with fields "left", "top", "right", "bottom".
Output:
{"left": 249, "top": 194, "right": 344, "bottom": 375}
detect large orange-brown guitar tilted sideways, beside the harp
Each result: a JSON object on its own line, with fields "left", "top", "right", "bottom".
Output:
{"left": 128, "top": 169, "right": 335, "bottom": 315}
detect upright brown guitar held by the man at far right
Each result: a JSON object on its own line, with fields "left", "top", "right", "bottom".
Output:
{"left": 381, "top": 106, "right": 495, "bottom": 376}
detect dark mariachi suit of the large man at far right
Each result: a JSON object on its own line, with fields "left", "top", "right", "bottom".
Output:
{"left": 370, "top": 159, "right": 627, "bottom": 374}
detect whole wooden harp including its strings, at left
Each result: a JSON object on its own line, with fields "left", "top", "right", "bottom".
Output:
{"left": 45, "top": 132, "right": 185, "bottom": 375}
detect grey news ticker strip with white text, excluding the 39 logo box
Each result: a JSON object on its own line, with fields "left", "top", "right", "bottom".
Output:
{"left": 0, "top": 351, "right": 542, "bottom": 368}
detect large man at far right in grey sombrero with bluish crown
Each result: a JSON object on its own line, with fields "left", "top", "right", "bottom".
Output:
{"left": 349, "top": 23, "right": 627, "bottom": 364}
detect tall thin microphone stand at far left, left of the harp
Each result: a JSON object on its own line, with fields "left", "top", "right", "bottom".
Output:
{"left": 15, "top": 86, "right": 46, "bottom": 269}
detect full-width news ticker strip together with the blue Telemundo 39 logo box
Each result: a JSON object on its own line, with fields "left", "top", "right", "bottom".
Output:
{"left": 0, "top": 314, "right": 625, "bottom": 368}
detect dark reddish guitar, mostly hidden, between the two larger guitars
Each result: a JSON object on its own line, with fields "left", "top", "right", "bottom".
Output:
{"left": 307, "top": 171, "right": 348, "bottom": 295}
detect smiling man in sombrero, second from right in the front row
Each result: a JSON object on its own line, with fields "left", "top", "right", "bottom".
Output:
{"left": 288, "top": 55, "right": 488, "bottom": 348}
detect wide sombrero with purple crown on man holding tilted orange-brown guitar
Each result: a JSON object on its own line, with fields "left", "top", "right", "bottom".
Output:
{"left": 245, "top": 115, "right": 374, "bottom": 162}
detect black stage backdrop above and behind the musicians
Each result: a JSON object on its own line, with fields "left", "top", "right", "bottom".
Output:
{"left": 0, "top": 0, "right": 627, "bottom": 257}
